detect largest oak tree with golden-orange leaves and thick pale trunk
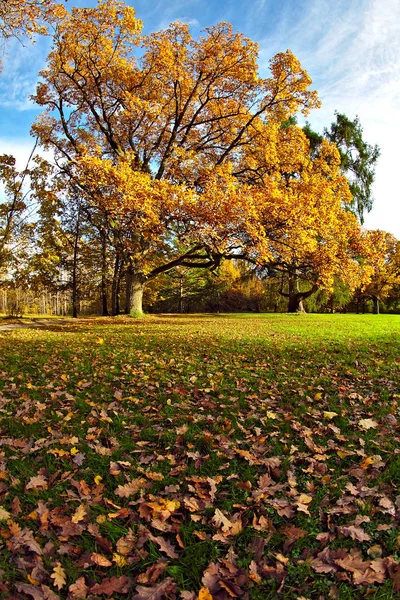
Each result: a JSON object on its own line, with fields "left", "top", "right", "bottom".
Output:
{"left": 33, "top": 0, "right": 318, "bottom": 312}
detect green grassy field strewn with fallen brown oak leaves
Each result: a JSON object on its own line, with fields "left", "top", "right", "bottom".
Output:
{"left": 0, "top": 315, "right": 400, "bottom": 600}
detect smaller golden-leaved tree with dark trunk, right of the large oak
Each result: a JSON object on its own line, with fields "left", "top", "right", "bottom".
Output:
{"left": 248, "top": 126, "right": 380, "bottom": 312}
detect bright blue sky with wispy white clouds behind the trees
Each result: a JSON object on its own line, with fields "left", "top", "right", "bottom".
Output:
{"left": 0, "top": 0, "right": 400, "bottom": 238}
